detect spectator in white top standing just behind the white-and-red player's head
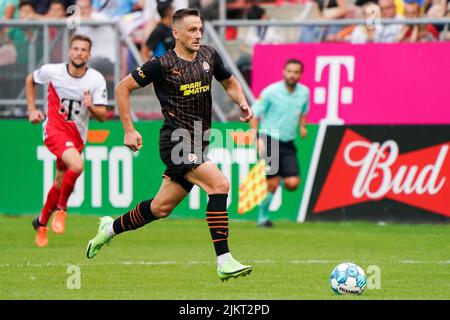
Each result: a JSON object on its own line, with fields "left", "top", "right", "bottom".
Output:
{"left": 75, "top": 0, "right": 116, "bottom": 80}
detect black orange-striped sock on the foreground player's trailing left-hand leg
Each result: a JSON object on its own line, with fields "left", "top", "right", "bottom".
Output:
{"left": 113, "top": 199, "right": 158, "bottom": 234}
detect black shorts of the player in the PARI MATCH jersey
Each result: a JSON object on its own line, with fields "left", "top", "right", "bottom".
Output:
{"left": 159, "top": 126, "right": 209, "bottom": 193}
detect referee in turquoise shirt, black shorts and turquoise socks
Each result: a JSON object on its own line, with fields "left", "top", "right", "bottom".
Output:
{"left": 250, "top": 59, "right": 309, "bottom": 227}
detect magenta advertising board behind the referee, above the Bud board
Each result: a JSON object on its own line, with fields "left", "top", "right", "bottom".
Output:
{"left": 252, "top": 42, "right": 450, "bottom": 125}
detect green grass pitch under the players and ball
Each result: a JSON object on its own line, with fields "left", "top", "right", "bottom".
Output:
{"left": 0, "top": 215, "right": 450, "bottom": 300}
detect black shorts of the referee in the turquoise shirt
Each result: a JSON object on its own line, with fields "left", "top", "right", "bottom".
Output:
{"left": 261, "top": 135, "right": 300, "bottom": 178}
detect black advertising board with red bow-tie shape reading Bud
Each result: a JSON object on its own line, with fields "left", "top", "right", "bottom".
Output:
{"left": 306, "top": 125, "right": 450, "bottom": 222}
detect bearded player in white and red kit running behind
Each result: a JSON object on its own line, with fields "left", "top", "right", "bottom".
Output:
{"left": 25, "top": 35, "right": 108, "bottom": 247}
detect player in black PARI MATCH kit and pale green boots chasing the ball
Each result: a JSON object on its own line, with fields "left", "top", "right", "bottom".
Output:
{"left": 87, "top": 9, "right": 253, "bottom": 281}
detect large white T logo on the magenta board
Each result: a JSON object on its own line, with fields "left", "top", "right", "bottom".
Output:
{"left": 314, "top": 56, "right": 355, "bottom": 124}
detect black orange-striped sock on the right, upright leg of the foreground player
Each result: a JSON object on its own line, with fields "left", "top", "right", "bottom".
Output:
{"left": 206, "top": 194, "right": 230, "bottom": 256}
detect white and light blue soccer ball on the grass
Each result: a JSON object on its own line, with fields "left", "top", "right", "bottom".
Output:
{"left": 330, "top": 262, "right": 367, "bottom": 295}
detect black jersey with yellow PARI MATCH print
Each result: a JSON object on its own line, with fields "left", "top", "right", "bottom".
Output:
{"left": 131, "top": 45, "right": 231, "bottom": 133}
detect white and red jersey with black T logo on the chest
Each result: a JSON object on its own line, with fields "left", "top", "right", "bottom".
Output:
{"left": 33, "top": 63, "right": 108, "bottom": 143}
